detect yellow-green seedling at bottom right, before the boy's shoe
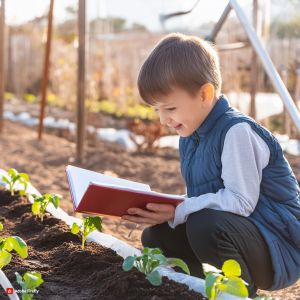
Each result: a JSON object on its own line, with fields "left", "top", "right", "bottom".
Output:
{"left": 202, "top": 259, "right": 248, "bottom": 300}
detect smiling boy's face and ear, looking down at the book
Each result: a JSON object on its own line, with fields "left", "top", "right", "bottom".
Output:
{"left": 153, "top": 87, "right": 214, "bottom": 137}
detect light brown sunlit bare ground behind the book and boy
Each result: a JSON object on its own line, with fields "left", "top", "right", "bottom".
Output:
{"left": 0, "top": 121, "right": 300, "bottom": 300}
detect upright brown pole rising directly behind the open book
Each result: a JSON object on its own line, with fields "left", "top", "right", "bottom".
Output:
{"left": 76, "top": 0, "right": 85, "bottom": 162}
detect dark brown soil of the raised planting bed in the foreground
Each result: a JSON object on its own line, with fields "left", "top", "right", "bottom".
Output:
{"left": 0, "top": 188, "right": 206, "bottom": 300}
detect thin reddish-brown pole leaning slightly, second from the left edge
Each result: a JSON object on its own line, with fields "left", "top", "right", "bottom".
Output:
{"left": 38, "top": 0, "right": 54, "bottom": 140}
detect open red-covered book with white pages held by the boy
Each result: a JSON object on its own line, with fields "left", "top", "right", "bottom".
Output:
{"left": 66, "top": 165, "right": 184, "bottom": 217}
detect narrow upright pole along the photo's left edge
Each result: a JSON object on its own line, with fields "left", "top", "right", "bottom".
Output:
{"left": 0, "top": 0, "right": 5, "bottom": 134}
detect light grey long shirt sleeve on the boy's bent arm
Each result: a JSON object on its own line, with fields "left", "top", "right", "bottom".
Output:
{"left": 168, "top": 122, "right": 270, "bottom": 228}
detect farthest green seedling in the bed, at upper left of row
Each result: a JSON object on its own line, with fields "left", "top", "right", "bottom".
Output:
{"left": 2, "top": 168, "right": 29, "bottom": 196}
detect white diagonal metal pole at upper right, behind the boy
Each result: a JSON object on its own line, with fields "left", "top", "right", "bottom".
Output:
{"left": 230, "top": 0, "right": 300, "bottom": 131}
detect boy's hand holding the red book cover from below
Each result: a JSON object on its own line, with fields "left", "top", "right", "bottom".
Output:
{"left": 122, "top": 203, "right": 175, "bottom": 225}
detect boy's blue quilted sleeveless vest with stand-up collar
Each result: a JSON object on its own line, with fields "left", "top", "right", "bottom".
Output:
{"left": 179, "top": 96, "right": 300, "bottom": 290}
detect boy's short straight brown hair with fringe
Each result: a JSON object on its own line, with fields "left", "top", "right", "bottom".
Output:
{"left": 138, "top": 33, "right": 222, "bottom": 104}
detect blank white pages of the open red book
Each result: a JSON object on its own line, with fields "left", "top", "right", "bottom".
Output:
{"left": 66, "top": 165, "right": 151, "bottom": 207}
